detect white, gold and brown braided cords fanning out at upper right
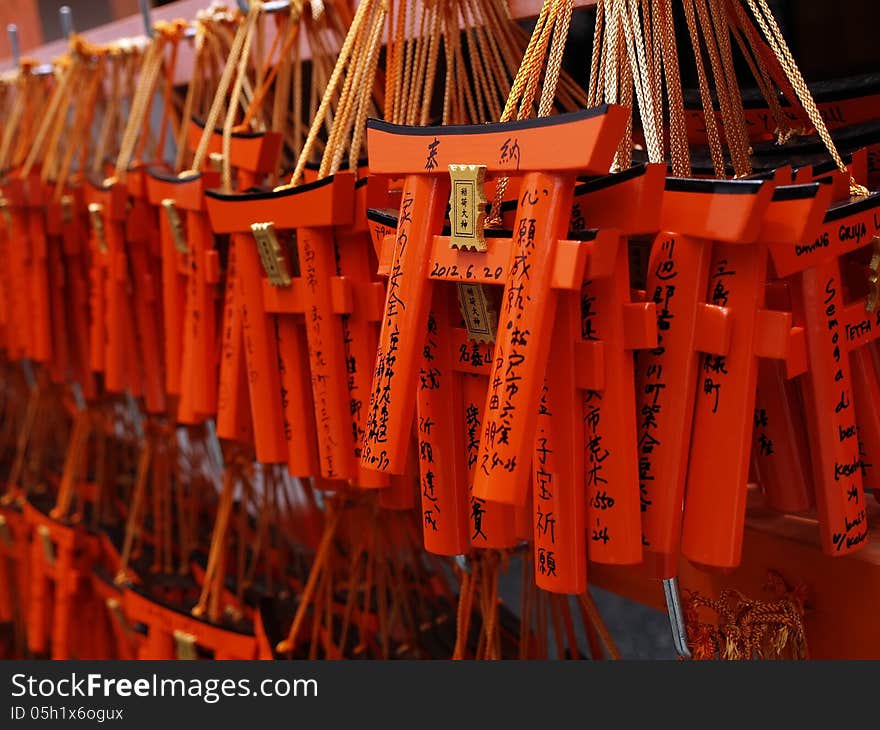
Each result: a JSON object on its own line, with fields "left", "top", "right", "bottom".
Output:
{"left": 589, "top": 0, "right": 867, "bottom": 195}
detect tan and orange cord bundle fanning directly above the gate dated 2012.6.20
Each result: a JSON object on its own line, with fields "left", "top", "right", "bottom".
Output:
{"left": 289, "top": 0, "right": 584, "bottom": 186}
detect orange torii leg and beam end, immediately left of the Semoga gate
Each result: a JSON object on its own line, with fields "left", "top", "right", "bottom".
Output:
{"left": 682, "top": 179, "right": 831, "bottom": 569}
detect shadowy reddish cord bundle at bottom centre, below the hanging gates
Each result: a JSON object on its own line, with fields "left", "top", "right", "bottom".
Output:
{"left": 276, "top": 498, "right": 451, "bottom": 659}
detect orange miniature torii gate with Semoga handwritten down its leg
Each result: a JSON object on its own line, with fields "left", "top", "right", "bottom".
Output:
{"left": 770, "top": 164, "right": 880, "bottom": 555}
